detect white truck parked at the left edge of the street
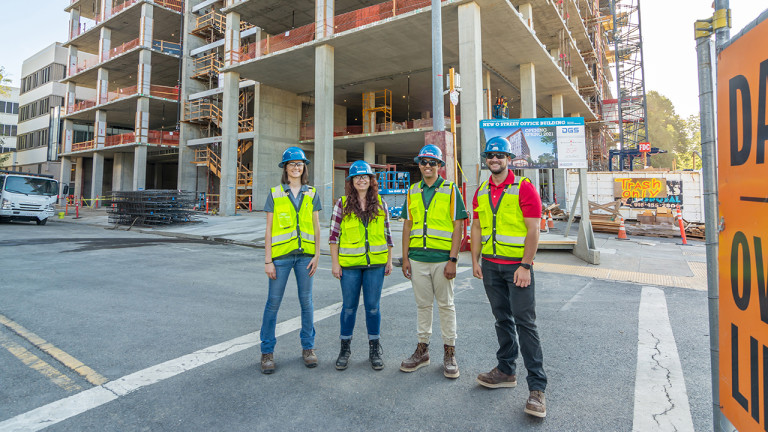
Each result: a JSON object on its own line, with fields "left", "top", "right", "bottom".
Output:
{"left": 0, "top": 170, "right": 69, "bottom": 225}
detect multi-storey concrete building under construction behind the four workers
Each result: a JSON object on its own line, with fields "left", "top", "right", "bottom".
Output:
{"left": 62, "top": 0, "right": 615, "bottom": 215}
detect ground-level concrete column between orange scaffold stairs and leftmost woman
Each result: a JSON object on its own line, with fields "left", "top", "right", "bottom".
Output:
{"left": 219, "top": 72, "right": 240, "bottom": 216}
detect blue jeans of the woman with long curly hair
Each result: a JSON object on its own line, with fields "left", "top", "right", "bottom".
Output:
{"left": 340, "top": 267, "right": 384, "bottom": 339}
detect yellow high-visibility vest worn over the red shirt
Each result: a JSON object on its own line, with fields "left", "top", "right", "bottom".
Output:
{"left": 475, "top": 177, "right": 530, "bottom": 261}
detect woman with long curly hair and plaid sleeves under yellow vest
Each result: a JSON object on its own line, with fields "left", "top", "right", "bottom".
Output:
{"left": 328, "top": 161, "right": 394, "bottom": 370}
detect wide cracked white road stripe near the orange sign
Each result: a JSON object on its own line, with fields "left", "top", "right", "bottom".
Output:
{"left": 632, "top": 286, "right": 693, "bottom": 432}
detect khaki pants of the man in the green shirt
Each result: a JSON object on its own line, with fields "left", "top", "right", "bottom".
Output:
{"left": 411, "top": 260, "right": 456, "bottom": 346}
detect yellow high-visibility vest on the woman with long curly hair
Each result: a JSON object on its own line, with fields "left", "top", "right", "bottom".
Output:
{"left": 339, "top": 196, "right": 388, "bottom": 267}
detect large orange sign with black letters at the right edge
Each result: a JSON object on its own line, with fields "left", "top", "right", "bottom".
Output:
{"left": 717, "top": 13, "right": 768, "bottom": 431}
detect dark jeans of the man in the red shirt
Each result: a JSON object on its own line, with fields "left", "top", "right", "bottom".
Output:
{"left": 482, "top": 260, "right": 547, "bottom": 391}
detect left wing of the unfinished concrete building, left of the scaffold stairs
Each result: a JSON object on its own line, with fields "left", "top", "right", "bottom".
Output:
{"left": 60, "top": 0, "right": 184, "bottom": 200}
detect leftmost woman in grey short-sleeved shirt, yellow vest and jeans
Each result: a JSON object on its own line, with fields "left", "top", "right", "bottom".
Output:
{"left": 261, "top": 147, "right": 322, "bottom": 374}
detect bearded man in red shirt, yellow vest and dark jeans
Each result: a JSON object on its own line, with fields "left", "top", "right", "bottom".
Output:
{"left": 471, "top": 137, "right": 547, "bottom": 417}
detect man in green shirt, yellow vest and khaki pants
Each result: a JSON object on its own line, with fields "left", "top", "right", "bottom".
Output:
{"left": 400, "top": 144, "right": 467, "bottom": 378}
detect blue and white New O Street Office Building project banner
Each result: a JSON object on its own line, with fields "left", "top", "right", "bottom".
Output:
{"left": 480, "top": 117, "right": 587, "bottom": 169}
